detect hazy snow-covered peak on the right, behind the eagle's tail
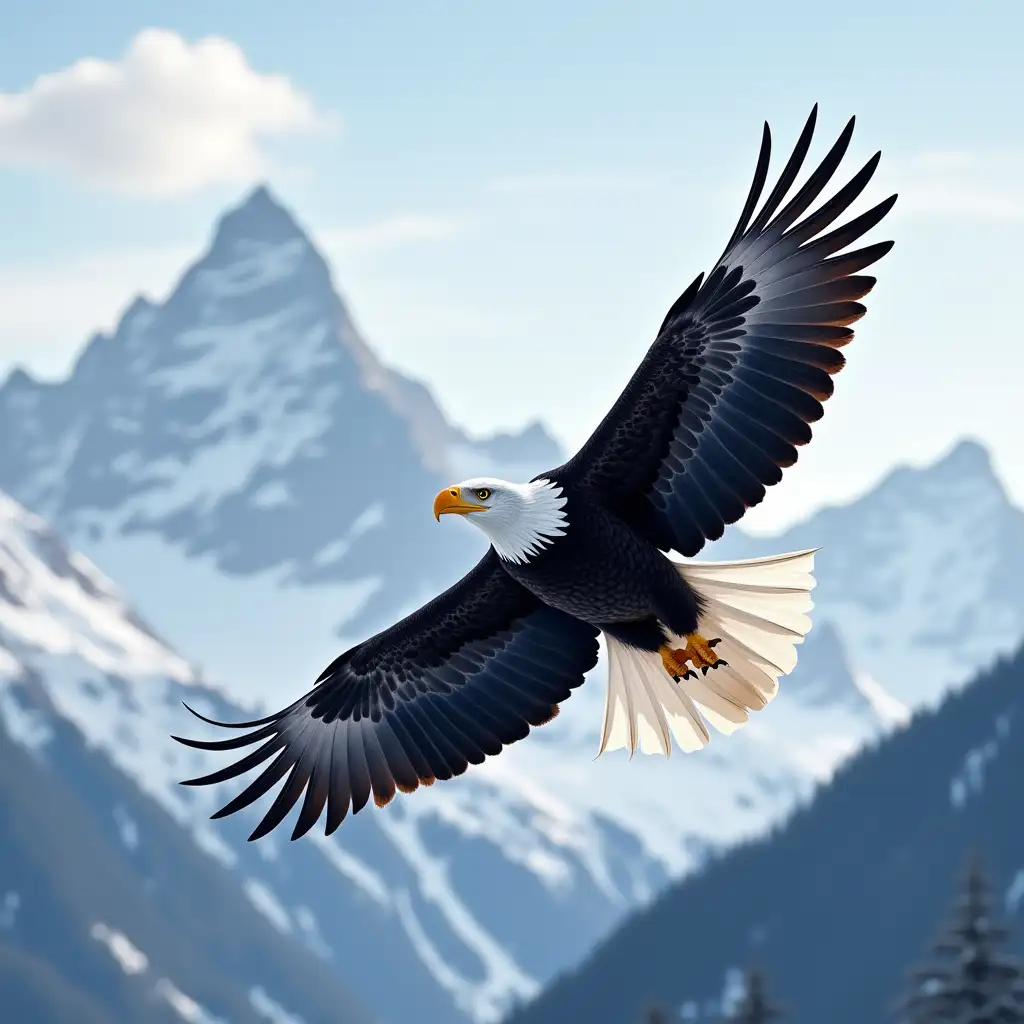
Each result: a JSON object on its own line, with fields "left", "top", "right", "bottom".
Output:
{"left": 709, "top": 440, "right": 1024, "bottom": 707}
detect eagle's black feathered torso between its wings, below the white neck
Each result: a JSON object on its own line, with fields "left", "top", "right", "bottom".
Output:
{"left": 496, "top": 473, "right": 697, "bottom": 651}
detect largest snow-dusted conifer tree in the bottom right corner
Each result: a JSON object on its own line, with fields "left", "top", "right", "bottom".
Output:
{"left": 900, "top": 856, "right": 1024, "bottom": 1024}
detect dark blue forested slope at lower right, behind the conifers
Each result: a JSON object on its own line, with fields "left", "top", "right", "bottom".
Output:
{"left": 509, "top": 651, "right": 1024, "bottom": 1024}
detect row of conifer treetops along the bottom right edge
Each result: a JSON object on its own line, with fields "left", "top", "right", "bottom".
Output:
{"left": 640, "top": 856, "right": 1024, "bottom": 1024}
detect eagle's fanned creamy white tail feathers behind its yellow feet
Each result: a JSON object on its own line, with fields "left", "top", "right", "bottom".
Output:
{"left": 598, "top": 549, "right": 817, "bottom": 757}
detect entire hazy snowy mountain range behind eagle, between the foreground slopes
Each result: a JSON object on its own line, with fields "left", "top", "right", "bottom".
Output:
{"left": 0, "top": 189, "right": 1024, "bottom": 1024}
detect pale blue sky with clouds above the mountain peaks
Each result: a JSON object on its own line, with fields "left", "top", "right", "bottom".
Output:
{"left": 0, "top": 6, "right": 1024, "bottom": 528}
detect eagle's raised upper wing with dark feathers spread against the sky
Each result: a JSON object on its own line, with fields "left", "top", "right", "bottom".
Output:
{"left": 544, "top": 106, "right": 896, "bottom": 557}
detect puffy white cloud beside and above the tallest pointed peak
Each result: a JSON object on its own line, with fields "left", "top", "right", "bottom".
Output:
{"left": 0, "top": 29, "right": 329, "bottom": 197}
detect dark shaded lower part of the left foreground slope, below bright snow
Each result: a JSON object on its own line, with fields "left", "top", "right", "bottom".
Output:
{"left": 0, "top": 683, "right": 370, "bottom": 1024}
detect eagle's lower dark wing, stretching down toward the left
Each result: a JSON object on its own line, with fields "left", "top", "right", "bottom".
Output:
{"left": 174, "top": 549, "right": 598, "bottom": 841}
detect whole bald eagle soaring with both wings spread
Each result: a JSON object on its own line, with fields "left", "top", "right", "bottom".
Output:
{"left": 174, "top": 106, "right": 896, "bottom": 840}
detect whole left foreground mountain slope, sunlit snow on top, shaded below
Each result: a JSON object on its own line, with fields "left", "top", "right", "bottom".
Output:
{"left": 0, "top": 498, "right": 370, "bottom": 1024}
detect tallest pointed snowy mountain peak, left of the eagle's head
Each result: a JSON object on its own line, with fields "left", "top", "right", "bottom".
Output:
{"left": 0, "top": 188, "right": 559, "bottom": 696}
